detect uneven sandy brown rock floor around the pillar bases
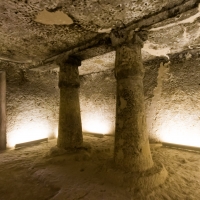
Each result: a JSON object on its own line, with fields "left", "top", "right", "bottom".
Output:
{"left": 0, "top": 135, "right": 200, "bottom": 200}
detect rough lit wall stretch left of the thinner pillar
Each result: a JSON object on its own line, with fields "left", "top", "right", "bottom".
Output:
{"left": 0, "top": 62, "right": 59, "bottom": 147}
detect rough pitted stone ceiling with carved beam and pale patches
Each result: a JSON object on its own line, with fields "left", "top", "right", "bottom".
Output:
{"left": 0, "top": 0, "right": 200, "bottom": 69}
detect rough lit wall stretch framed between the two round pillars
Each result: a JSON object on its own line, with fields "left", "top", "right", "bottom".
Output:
{"left": 80, "top": 70, "right": 116, "bottom": 134}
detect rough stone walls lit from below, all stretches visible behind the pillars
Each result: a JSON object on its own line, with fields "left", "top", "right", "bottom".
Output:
{"left": 0, "top": 51, "right": 200, "bottom": 146}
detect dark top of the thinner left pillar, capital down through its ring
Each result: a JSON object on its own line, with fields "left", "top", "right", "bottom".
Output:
{"left": 56, "top": 56, "right": 81, "bottom": 88}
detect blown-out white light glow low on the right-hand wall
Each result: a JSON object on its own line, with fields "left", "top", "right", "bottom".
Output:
{"left": 158, "top": 113, "right": 200, "bottom": 147}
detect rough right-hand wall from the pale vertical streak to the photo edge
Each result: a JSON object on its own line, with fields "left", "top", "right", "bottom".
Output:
{"left": 147, "top": 51, "right": 200, "bottom": 146}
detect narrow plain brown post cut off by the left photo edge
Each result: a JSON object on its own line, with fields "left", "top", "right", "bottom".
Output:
{"left": 0, "top": 71, "right": 6, "bottom": 150}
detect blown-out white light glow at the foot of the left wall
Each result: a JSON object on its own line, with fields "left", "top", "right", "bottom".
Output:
{"left": 7, "top": 120, "right": 52, "bottom": 148}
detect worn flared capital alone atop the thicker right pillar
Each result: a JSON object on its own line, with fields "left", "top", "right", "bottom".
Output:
{"left": 110, "top": 30, "right": 148, "bottom": 48}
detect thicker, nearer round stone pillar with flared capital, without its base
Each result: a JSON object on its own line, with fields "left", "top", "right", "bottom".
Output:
{"left": 111, "top": 31, "right": 153, "bottom": 172}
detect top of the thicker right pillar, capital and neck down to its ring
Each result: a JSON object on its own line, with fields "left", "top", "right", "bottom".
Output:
{"left": 112, "top": 31, "right": 147, "bottom": 80}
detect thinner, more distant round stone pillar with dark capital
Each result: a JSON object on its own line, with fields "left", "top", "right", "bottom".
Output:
{"left": 57, "top": 56, "right": 83, "bottom": 149}
